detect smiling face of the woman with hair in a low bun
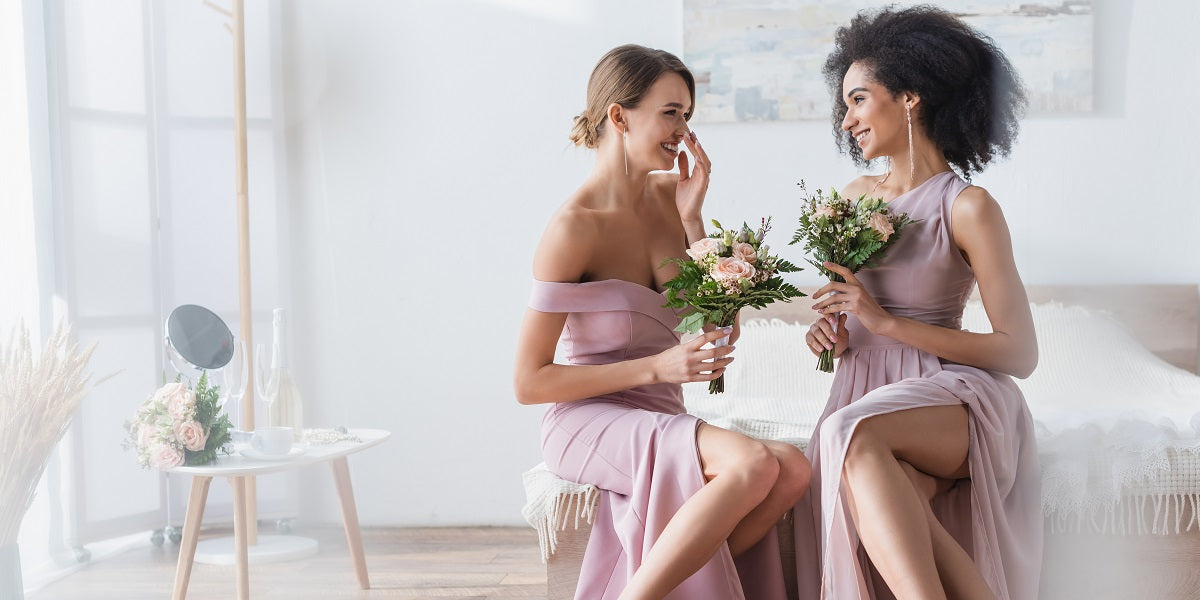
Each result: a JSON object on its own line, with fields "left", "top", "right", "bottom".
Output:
{"left": 623, "top": 72, "right": 691, "bottom": 172}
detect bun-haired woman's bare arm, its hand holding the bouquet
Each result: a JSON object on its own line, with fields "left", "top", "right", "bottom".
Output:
{"left": 512, "top": 211, "right": 733, "bottom": 404}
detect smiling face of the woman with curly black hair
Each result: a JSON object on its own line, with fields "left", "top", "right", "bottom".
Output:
{"left": 841, "top": 62, "right": 916, "bottom": 160}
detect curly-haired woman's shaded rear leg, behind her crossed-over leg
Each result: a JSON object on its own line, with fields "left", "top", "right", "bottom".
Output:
{"left": 900, "top": 461, "right": 996, "bottom": 600}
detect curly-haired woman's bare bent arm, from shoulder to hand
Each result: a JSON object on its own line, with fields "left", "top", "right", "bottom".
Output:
{"left": 814, "top": 187, "right": 1038, "bottom": 378}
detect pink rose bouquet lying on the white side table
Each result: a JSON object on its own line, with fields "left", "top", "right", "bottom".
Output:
{"left": 125, "top": 372, "right": 233, "bottom": 469}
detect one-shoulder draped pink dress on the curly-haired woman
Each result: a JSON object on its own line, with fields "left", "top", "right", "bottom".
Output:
{"left": 797, "top": 172, "right": 1043, "bottom": 600}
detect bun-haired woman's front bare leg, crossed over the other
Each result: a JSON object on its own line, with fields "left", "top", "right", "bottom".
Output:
{"left": 620, "top": 424, "right": 777, "bottom": 600}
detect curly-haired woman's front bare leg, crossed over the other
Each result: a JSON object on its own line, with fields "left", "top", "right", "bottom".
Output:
{"left": 842, "top": 404, "right": 974, "bottom": 600}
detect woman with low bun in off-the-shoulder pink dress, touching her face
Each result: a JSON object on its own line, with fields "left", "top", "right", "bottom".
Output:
{"left": 514, "top": 46, "right": 809, "bottom": 600}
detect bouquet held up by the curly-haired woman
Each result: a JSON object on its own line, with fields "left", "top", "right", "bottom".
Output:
{"left": 791, "top": 181, "right": 912, "bottom": 373}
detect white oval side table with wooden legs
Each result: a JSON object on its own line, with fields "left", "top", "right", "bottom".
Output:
{"left": 167, "top": 430, "right": 391, "bottom": 600}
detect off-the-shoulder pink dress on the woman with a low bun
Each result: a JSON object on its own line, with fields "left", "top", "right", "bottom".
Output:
{"left": 529, "top": 280, "right": 786, "bottom": 600}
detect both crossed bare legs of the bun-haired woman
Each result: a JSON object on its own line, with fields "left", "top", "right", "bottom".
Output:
{"left": 620, "top": 424, "right": 811, "bottom": 599}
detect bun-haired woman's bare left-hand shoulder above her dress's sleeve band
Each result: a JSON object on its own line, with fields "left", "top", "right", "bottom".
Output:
{"left": 533, "top": 192, "right": 600, "bottom": 282}
